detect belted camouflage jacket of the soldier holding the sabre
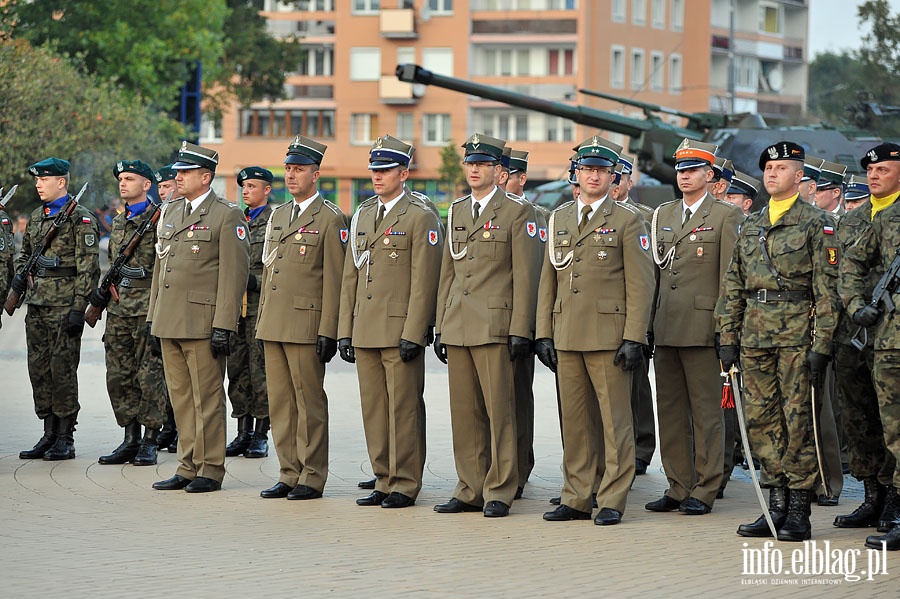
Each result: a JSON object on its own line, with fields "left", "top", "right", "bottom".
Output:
{"left": 716, "top": 198, "right": 839, "bottom": 355}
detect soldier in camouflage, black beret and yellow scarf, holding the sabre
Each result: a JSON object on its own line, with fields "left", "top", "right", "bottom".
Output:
{"left": 717, "top": 141, "right": 838, "bottom": 541}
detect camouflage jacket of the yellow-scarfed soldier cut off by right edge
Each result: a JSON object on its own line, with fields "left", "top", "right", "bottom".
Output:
{"left": 840, "top": 202, "right": 900, "bottom": 351}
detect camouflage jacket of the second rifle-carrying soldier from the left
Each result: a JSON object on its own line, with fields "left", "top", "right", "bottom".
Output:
{"left": 107, "top": 206, "right": 156, "bottom": 317}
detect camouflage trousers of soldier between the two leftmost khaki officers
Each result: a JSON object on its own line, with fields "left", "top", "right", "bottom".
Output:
{"left": 226, "top": 314, "right": 269, "bottom": 418}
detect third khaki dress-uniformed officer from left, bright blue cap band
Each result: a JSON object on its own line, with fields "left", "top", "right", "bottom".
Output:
{"left": 338, "top": 135, "right": 443, "bottom": 508}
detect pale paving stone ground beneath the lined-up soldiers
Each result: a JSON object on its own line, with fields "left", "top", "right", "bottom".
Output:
{"left": 0, "top": 310, "right": 900, "bottom": 599}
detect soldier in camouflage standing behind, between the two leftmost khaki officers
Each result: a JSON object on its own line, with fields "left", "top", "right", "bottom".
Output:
{"left": 225, "top": 166, "right": 274, "bottom": 458}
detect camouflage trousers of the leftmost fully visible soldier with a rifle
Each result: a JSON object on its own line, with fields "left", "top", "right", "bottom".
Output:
{"left": 25, "top": 304, "right": 81, "bottom": 420}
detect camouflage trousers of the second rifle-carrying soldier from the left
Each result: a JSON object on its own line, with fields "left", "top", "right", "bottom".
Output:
{"left": 103, "top": 314, "right": 169, "bottom": 428}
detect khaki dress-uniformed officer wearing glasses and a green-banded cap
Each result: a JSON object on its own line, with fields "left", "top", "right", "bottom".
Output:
{"left": 535, "top": 135, "right": 655, "bottom": 525}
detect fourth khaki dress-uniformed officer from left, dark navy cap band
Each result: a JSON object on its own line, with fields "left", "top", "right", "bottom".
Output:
{"left": 434, "top": 133, "right": 537, "bottom": 517}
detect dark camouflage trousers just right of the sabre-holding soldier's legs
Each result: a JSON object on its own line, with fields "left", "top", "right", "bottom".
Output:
{"left": 834, "top": 343, "right": 896, "bottom": 485}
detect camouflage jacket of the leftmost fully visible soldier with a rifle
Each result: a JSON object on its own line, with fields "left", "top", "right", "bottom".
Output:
{"left": 16, "top": 205, "right": 100, "bottom": 312}
